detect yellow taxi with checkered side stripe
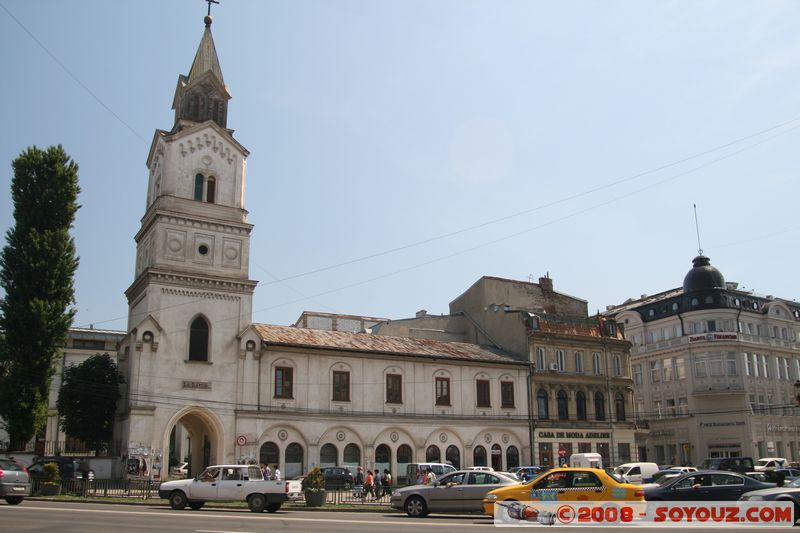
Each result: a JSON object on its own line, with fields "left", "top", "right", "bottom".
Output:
{"left": 483, "top": 468, "right": 644, "bottom": 515}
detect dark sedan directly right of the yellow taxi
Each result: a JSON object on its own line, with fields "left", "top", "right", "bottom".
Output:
{"left": 644, "top": 470, "right": 775, "bottom": 502}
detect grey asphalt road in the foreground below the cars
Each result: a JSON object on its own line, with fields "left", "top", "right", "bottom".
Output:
{"left": 0, "top": 500, "right": 788, "bottom": 533}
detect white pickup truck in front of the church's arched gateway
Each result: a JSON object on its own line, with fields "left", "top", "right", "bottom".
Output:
{"left": 158, "top": 465, "right": 302, "bottom": 513}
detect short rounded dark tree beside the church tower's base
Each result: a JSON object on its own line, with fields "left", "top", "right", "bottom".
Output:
{"left": 57, "top": 354, "right": 125, "bottom": 450}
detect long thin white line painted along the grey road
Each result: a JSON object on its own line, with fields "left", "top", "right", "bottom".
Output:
{"left": 14, "top": 505, "right": 494, "bottom": 533}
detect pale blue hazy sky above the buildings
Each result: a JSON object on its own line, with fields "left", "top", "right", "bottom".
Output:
{"left": 0, "top": 0, "right": 800, "bottom": 330}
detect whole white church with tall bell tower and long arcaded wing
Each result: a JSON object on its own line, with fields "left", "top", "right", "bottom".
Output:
{"left": 116, "top": 13, "right": 532, "bottom": 478}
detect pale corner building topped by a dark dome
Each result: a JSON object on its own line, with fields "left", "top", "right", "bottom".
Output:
{"left": 606, "top": 254, "right": 800, "bottom": 465}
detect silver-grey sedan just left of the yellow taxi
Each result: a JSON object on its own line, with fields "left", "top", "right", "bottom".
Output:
{"left": 391, "top": 470, "right": 519, "bottom": 518}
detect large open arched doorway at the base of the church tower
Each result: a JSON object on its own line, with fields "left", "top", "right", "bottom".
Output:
{"left": 163, "top": 410, "right": 221, "bottom": 478}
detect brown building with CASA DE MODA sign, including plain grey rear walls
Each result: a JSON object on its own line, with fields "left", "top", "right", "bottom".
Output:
{"left": 372, "top": 276, "right": 636, "bottom": 466}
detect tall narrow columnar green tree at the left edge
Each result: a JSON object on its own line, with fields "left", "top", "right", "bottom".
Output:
{"left": 0, "top": 146, "right": 80, "bottom": 448}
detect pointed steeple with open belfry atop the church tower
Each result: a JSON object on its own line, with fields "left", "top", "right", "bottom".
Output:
{"left": 172, "top": 15, "right": 231, "bottom": 133}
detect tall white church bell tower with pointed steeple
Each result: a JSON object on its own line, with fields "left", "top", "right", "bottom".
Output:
{"left": 120, "top": 10, "right": 256, "bottom": 466}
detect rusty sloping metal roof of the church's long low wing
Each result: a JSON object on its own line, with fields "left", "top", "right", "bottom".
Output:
{"left": 253, "top": 324, "right": 526, "bottom": 365}
